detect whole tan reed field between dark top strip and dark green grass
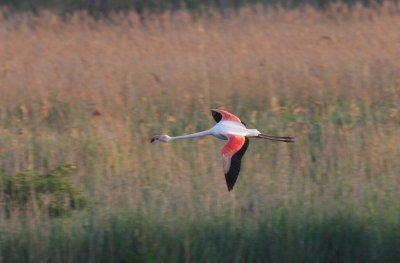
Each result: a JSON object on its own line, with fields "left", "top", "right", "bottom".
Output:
{"left": 0, "top": 5, "right": 400, "bottom": 262}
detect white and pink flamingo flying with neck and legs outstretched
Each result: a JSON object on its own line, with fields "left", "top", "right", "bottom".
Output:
{"left": 150, "top": 109, "right": 294, "bottom": 191}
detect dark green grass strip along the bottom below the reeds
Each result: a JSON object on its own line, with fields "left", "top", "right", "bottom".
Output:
{"left": 2, "top": 211, "right": 400, "bottom": 263}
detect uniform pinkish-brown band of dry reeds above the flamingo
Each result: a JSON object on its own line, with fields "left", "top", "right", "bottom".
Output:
{"left": 0, "top": 2, "right": 400, "bottom": 114}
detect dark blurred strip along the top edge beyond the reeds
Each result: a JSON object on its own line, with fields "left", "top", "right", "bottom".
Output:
{"left": 0, "top": 0, "right": 388, "bottom": 15}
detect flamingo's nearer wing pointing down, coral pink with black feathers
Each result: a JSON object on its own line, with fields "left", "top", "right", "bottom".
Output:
{"left": 222, "top": 135, "right": 249, "bottom": 191}
